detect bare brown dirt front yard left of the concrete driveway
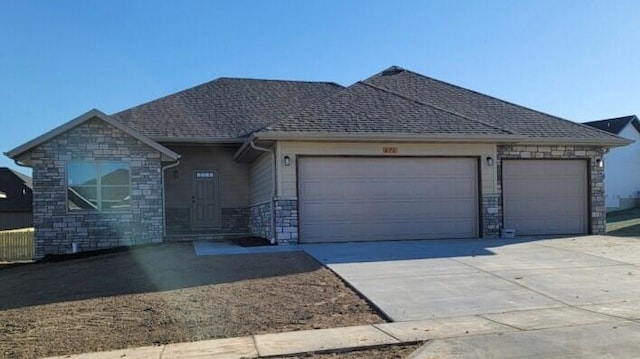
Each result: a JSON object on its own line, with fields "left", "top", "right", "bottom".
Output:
{"left": 0, "top": 244, "right": 384, "bottom": 358}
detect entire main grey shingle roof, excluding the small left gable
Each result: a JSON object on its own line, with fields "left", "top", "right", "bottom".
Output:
{"left": 113, "top": 66, "right": 620, "bottom": 142}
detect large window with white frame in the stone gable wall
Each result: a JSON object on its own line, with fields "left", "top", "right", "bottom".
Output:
{"left": 67, "top": 161, "right": 131, "bottom": 211}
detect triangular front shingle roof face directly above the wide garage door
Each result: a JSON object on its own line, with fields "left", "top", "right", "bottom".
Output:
{"left": 260, "top": 82, "right": 509, "bottom": 135}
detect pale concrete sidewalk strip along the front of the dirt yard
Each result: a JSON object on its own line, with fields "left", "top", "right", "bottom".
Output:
{"left": 46, "top": 316, "right": 515, "bottom": 359}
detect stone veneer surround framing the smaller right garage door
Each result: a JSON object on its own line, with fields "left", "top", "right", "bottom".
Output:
{"left": 496, "top": 146, "right": 606, "bottom": 234}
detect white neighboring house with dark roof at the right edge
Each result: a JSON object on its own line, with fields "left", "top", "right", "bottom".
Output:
{"left": 585, "top": 115, "right": 640, "bottom": 211}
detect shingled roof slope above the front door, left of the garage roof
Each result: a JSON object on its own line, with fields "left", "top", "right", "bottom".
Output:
{"left": 112, "top": 78, "right": 342, "bottom": 139}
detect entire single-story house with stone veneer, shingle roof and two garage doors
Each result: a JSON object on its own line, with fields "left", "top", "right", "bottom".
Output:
{"left": 2, "top": 67, "right": 630, "bottom": 257}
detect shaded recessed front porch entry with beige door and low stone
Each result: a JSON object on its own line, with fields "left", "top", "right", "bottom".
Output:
{"left": 163, "top": 144, "right": 271, "bottom": 241}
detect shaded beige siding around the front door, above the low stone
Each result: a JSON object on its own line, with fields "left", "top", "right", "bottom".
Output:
{"left": 165, "top": 145, "right": 249, "bottom": 208}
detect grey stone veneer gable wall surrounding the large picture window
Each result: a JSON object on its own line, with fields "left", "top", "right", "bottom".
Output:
{"left": 31, "top": 119, "right": 162, "bottom": 259}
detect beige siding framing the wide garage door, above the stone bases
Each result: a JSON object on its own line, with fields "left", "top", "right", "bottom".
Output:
{"left": 276, "top": 142, "right": 497, "bottom": 197}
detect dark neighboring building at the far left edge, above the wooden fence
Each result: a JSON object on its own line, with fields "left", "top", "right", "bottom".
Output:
{"left": 0, "top": 167, "right": 33, "bottom": 230}
